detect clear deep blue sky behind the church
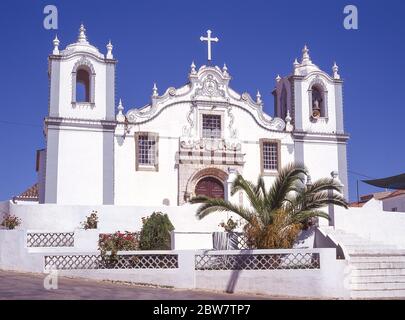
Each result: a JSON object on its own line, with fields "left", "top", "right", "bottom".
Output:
{"left": 0, "top": 0, "right": 405, "bottom": 199}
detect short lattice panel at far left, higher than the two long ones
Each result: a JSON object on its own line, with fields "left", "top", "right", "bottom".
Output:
{"left": 27, "top": 232, "right": 74, "bottom": 247}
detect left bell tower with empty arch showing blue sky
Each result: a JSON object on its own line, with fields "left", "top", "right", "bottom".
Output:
{"left": 40, "top": 25, "right": 117, "bottom": 205}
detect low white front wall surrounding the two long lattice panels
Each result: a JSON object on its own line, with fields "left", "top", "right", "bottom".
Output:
{"left": 0, "top": 230, "right": 350, "bottom": 298}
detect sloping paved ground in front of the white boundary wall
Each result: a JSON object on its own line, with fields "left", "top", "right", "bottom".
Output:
{"left": 0, "top": 271, "right": 281, "bottom": 300}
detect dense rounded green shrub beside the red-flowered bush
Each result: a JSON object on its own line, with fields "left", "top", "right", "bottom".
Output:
{"left": 139, "top": 212, "right": 174, "bottom": 250}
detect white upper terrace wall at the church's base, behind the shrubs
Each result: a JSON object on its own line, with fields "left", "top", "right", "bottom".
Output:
{"left": 10, "top": 204, "right": 240, "bottom": 233}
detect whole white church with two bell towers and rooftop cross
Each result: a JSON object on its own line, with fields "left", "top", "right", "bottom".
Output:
{"left": 37, "top": 26, "right": 348, "bottom": 206}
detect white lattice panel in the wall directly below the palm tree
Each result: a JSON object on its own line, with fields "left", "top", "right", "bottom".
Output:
{"left": 195, "top": 253, "right": 320, "bottom": 270}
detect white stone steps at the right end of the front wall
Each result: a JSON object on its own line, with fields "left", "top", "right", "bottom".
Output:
{"left": 318, "top": 229, "right": 405, "bottom": 299}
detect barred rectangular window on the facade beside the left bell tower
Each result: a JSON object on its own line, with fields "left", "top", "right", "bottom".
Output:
{"left": 135, "top": 132, "right": 158, "bottom": 171}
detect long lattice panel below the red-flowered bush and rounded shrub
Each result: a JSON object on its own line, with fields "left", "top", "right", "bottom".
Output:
{"left": 45, "top": 254, "right": 178, "bottom": 270}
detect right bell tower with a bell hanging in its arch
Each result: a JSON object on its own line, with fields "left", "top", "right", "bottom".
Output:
{"left": 273, "top": 46, "right": 349, "bottom": 198}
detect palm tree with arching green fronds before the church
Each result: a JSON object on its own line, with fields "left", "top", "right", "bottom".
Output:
{"left": 191, "top": 164, "right": 348, "bottom": 249}
